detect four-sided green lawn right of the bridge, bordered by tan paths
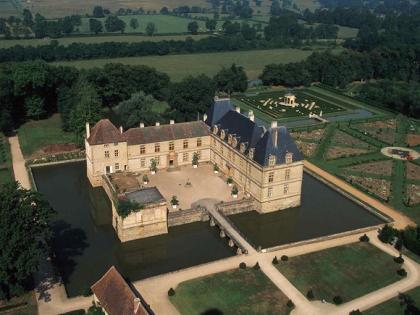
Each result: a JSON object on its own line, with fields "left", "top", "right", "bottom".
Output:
{"left": 277, "top": 242, "right": 401, "bottom": 302}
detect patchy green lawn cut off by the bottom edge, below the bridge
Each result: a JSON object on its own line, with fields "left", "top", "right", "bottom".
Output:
{"left": 170, "top": 268, "right": 289, "bottom": 315}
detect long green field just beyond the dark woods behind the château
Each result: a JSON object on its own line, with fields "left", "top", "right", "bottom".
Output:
{"left": 55, "top": 48, "right": 342, "bottom": 81}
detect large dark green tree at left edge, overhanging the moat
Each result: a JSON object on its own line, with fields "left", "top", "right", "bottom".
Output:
{"left": 0, "top": 182, "right": 54, "bottom": 299}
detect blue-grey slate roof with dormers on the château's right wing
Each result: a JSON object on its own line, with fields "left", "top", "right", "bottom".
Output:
{"left": 206, "top": 100, "right": 303, "bottom": 166}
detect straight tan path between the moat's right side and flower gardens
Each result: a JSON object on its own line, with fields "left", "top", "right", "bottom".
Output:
{"left": 304, "top": 160, "right": 416, "bottom": 229}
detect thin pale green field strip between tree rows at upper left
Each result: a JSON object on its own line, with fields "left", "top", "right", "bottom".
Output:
{"left": 0, "top": 34, "right": 208, "bottom": 48}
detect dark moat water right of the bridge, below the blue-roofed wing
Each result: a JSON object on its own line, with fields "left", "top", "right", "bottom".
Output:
{"left": 229, "top": 173, "right": 384, "bottom": 248}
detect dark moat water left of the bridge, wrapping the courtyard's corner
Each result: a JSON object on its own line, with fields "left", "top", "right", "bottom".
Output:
{"left": 32, "top": 162, "right": 235, "bottom": 296}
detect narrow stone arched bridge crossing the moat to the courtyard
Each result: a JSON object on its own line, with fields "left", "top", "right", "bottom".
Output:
{"left": 207, "top": 207, "right": 257, "bottom": 254}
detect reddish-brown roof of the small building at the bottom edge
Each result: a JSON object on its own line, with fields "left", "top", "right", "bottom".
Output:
{"left": 91, "top": 266, "right": 150, "bottom": 315}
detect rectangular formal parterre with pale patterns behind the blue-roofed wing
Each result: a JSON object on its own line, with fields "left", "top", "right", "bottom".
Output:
{"left": 236, "top": 89, "right": 346, "bottom": 119}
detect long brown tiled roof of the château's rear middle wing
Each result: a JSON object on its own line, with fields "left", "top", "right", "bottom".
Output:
{"left": 123, "top": 121, "right": 209, "bottom": 145}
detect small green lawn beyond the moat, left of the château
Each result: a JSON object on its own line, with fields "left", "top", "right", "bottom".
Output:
{"left": 18, "top": 114, "right": 74, "bottom": 158}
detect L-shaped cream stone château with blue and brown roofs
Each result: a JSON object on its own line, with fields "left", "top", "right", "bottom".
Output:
{"left": 85, "top": 99, "right": 303, "bottom": 241}
